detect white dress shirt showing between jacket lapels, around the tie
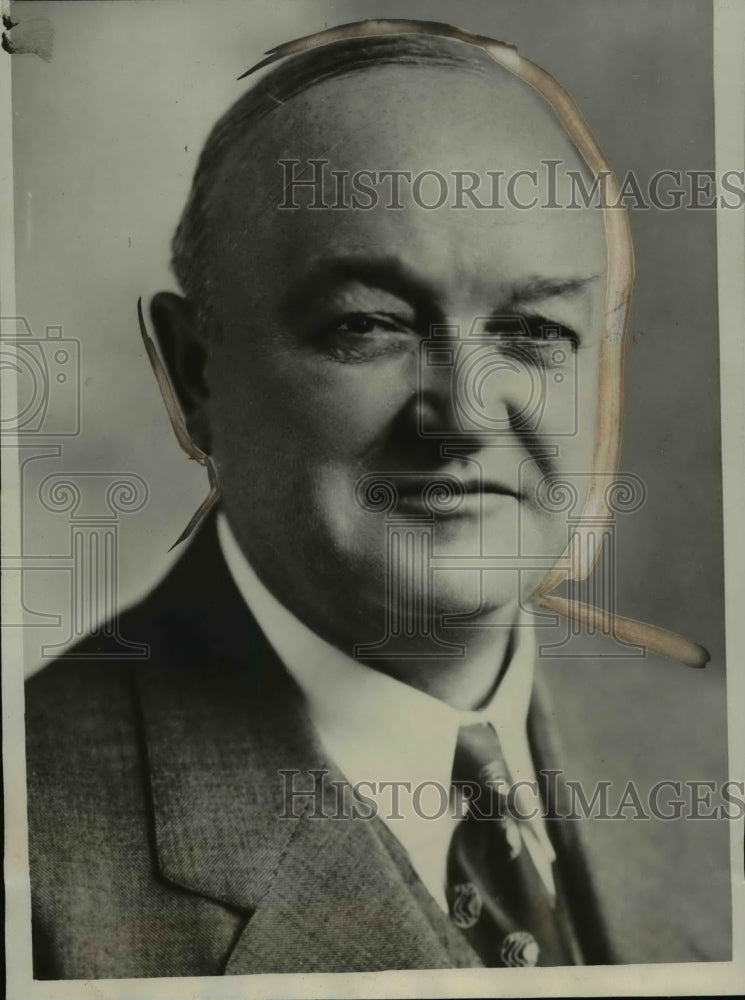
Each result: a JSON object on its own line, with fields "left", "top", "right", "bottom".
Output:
{"left": 217, "top": 511, "right": 554, "bottom": 912}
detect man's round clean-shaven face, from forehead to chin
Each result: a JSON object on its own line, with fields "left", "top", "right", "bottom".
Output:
{"left": 202, "top": 66, "right": 607, "bottom": 641}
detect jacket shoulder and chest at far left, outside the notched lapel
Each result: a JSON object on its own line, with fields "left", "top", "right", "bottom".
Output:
{"left": 26, "top": 647, "right": 242, "bottom": 979}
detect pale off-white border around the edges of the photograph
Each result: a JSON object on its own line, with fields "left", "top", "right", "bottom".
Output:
{"left": 0, "top": 0, "right": 745, "bottom": 1000}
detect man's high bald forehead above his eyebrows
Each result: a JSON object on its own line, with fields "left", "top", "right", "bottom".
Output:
{"left": 202, "top": 56, "right": 606, "bottom": 298}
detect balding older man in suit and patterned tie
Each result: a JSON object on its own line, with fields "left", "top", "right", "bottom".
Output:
{"left": 27, "top": 22, "right": 729, "bottom": 979}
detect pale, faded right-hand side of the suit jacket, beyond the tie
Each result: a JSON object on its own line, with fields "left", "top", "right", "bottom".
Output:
{"left": 531, "top": 637, "right": 731, "bottom": 964}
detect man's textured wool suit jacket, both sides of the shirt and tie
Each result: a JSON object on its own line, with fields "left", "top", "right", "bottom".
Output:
{"left": 26, "top": 522, "right": 731, "bottom": 979}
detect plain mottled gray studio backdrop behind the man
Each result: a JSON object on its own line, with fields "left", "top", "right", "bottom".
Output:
{"left": 8, "top": 0, "right": 723, "bottom": 679}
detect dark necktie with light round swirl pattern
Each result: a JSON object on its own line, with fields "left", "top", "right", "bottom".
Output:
{"left": 447, "top": 723, "right": 582, "bottom": 968}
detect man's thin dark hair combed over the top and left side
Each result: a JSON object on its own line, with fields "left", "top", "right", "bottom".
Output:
{"left": 171, "top": 34, "right": 507, "bottom": 333}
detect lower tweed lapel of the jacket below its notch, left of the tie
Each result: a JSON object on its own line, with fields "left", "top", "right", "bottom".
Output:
{"left": 227, "top": 775, "right": 480, "bottom": 973}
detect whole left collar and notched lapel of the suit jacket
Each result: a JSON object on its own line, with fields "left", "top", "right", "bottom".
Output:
{"left": 137, "top": 526, "right": 479, "bottom": 973}
